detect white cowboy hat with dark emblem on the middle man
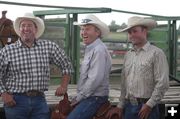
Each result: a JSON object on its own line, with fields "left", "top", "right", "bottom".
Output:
{"left": 73, "top": 15, "right": 109, "bottom": 37}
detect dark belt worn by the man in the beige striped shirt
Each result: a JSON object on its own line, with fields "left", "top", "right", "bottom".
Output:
{"left": 125, "top": 98, "right": 149, "bottom": 105}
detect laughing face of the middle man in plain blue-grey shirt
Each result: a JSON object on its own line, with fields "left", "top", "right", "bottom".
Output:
{"left": 80, "top": 24, "right": 100, "bottom": 45}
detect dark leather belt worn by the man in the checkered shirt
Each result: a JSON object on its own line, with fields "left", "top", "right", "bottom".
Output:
{"left": 13, "top": 90, "right": 44, "bottom": 97}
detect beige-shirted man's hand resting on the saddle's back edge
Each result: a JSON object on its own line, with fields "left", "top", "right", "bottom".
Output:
{"left": 106, "top": 107, "right": 123, "bottom": 119}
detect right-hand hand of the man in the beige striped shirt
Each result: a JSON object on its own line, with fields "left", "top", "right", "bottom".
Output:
{"left": 138, "top": 104, "right": 152, "bottom": 119}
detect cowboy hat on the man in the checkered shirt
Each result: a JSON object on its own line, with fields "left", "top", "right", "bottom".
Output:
{"left": 14, "top": 13, "right": 45, "bottom": 38}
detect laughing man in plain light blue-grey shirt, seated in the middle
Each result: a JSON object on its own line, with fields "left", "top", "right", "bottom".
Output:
{"left": 67, "top": 15, "right": 111, "bottom": 119}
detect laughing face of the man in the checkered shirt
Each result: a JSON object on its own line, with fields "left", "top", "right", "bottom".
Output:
{"left": 19, "top": 19, "right": 37, "bottom": 42}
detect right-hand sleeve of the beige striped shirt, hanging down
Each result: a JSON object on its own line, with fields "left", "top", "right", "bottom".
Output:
{"left": 146, "top": 51, "right": 169, "bottom": 108}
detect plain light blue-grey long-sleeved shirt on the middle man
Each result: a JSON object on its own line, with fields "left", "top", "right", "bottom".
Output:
{"left": 76, "top": 39, "right": 111, "bottom": 101}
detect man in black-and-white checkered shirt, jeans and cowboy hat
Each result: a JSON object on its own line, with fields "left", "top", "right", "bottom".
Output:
{"left": 0, "top": 13, "right": 72, "bottom": 119}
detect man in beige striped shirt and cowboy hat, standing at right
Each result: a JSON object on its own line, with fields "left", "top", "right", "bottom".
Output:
{"left": 109, "top": 16, "right": 169, "bottom": 119}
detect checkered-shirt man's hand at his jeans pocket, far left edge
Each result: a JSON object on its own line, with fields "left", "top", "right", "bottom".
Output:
{"left": 1, "top": 92, "right": 16, "bottom": 107}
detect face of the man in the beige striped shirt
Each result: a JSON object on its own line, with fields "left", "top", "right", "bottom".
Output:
{"left": 128, "top": 26, "right": 147, "bottom": 46}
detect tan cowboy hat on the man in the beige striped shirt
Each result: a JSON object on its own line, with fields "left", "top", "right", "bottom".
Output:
{"left": 119, "top": 16, "right": 157, "bottom": 32}
